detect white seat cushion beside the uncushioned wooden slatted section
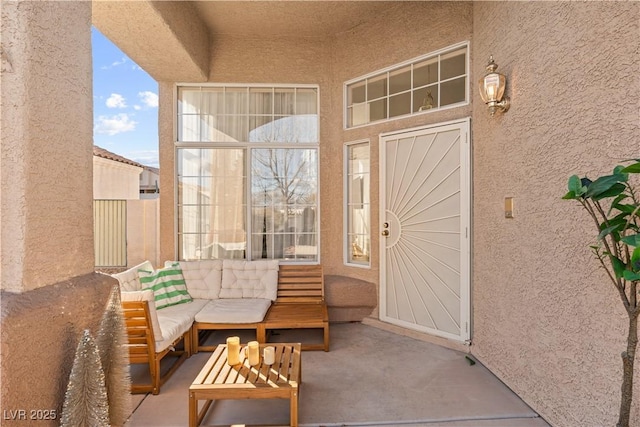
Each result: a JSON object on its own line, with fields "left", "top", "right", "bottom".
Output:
{"left": 195, "top": 298, "right": 271, "bottom": 323}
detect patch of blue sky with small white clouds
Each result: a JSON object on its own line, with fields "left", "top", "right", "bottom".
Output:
{"left": 91, "top": 28, "right": 158, "bottom": 167}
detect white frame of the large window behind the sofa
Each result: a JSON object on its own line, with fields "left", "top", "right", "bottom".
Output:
{"left": 172, "top": 82, "right": 322, "bottom": 264}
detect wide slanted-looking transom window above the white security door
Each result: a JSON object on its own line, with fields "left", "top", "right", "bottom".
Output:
{"left": 345, "top": 43, "right": 468, "bottom": 128}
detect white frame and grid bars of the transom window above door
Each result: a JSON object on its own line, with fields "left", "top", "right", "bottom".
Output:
{"left": 342, "top": 41, "right": 471, "bottom": 130}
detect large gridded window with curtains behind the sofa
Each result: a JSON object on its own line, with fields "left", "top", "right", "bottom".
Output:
{"left": 176, "top": 85, "right": 319, "bottom": 261}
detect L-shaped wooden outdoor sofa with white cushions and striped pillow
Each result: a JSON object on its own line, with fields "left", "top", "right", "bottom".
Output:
{"left": 113, "top": 260, "right": 329, "bottom": 394}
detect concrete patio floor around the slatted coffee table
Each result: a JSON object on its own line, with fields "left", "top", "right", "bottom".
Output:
{"left": 126, "top": 323, "right": 549, "bottom": 427}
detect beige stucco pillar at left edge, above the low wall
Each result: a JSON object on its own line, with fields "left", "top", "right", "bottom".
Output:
{"left": 1, "top": 2, "right": 93, "bottom": 292}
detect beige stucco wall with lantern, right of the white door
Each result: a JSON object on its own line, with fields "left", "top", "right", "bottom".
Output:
{"left": 472, "top": 2, "right": 640, "bottom": 427}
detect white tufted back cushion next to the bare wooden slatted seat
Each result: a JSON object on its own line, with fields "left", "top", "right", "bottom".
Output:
{"left": 220, "top": 259, "right": 279, "bottom": 301}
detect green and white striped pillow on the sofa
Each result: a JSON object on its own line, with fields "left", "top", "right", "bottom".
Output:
{"left": 138, "top": 263, "right": 193, "bottom": 310}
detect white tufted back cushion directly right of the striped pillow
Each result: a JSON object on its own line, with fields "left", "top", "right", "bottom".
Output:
{"left": 164, "top": 259, "right": 222, "bottom": 299}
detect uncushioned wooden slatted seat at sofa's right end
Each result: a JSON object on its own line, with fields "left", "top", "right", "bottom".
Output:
{"left": 257, "top": 265, "right": 329, "bottom": 351}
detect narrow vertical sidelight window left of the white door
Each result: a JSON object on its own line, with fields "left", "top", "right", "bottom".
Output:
{"left": 344, "top": 141, "right": 371, "bottom": 266}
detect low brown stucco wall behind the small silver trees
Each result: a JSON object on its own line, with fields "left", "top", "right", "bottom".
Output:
{"left": 0, "top": 273, "right": 118, "bottom": 427}
